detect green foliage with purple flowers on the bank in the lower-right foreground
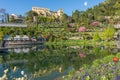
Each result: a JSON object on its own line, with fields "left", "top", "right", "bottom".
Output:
{"left": 62, "top": 53, "right": 120, "bottom": 80}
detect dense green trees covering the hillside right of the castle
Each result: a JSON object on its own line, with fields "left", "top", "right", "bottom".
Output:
{"left": 72, "top": 0, "right": 120, "bottom": 27}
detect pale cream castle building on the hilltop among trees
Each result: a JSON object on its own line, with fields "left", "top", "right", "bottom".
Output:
{"left": 32, "top": 7, "right": 64, "bottom": 18}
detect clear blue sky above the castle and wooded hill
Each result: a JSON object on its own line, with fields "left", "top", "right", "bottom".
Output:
{"left": 0, "top": 0, "right": 104, "bottom": 15}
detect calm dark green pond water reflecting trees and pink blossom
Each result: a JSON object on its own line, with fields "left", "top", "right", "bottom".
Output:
{"left": 0, "top": 45, "right": 119, "bottom": 80}
